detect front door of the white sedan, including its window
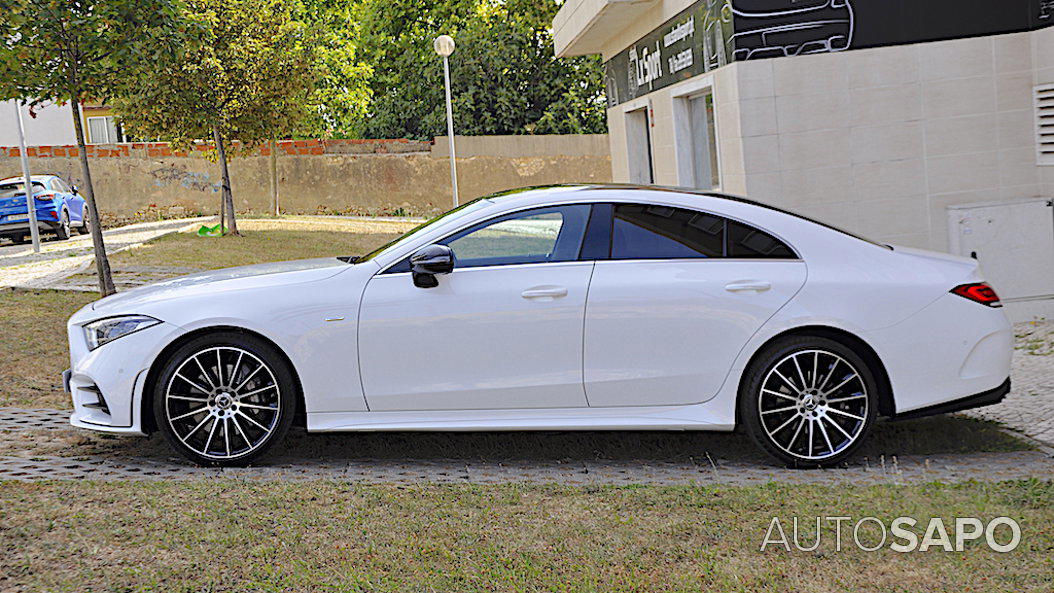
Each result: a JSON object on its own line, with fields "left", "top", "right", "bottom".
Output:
{"left": 358, "top": 204, "right": 593, "bottom": 411}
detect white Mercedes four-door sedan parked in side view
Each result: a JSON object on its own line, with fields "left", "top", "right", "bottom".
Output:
{"left": 64, "top": 185, "right": 1012, "bottom": 467}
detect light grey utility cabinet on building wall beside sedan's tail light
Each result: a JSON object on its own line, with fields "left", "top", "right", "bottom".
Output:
{"left": 948, "top": 198, "right": 1054, "bottom": 321}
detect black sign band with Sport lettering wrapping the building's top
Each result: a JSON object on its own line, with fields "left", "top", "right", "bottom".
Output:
{"left": 604, "top": 0, "right": 1054, "bottom": 106}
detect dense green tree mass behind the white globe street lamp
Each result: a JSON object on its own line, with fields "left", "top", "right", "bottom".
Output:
{"left": 358, "top": 0, "right": 606, "bottom": 139}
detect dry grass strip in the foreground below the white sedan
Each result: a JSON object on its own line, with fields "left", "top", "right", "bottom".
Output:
{"left": 0, "top": 480, "right": 1054, "bottom": 593}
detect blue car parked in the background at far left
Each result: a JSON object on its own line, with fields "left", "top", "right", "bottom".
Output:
{"left": 0, "top": 175, "right": 90, "bottom": 243}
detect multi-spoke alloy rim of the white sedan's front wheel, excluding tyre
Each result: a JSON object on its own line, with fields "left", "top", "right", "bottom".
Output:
{"left": 164, "top": 345, "right": 281, "bottom": 459}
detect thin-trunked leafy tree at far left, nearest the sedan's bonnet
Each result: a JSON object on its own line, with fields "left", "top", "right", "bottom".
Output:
{"left": 0, "top": 0, "right": 188, "bottom": 296}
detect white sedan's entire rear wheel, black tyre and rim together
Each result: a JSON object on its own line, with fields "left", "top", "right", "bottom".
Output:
{"left": 739, "top": 336, "right": 878, "bottom": 468}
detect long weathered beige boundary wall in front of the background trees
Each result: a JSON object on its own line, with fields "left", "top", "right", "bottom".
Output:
{"left": 0, "top": 136, "right": 611, "bottom": 219}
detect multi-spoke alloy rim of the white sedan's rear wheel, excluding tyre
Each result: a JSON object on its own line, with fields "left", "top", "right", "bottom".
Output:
{"left": 758, "top": 350, "right": 870, "bottom": 460}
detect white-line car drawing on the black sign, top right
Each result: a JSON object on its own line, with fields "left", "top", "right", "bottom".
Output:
{"left": 730, "top": 0, "right": 853, "bottom": 60}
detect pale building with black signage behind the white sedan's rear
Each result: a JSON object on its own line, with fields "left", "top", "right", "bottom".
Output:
{"left": 553, "top": 0, "right": 1054, "bottom": 315}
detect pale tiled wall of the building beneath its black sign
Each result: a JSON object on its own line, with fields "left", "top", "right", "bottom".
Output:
{"left": 608, "top": 27, "right": 1054, "bottom": 251}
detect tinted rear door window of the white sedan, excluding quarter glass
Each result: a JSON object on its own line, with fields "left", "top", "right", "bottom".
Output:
{"left": 611, "top": 204, "right": 724, "bottom": 259}
